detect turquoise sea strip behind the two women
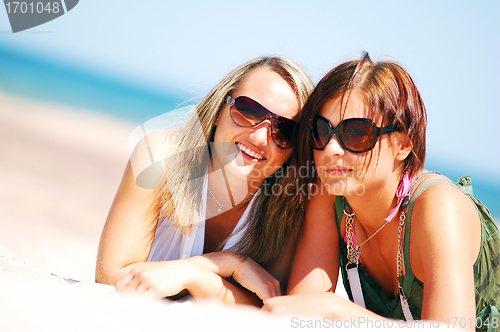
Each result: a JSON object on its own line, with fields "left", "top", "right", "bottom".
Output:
{"left": 0, "top": 43, "right": 500, "bottom": 221}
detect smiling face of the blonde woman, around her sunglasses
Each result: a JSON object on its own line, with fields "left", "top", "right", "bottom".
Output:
{"left": 213, "top": 67, "right": 299, "bottom": 185}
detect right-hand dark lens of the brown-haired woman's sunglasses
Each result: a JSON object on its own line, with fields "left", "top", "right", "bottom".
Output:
{"left": 339, "top": 119, "right": 375, "bottom": 152}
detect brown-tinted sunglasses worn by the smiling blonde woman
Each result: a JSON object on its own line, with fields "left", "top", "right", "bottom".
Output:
{"left": 226, "top": 96, "right": 297, "bottom": 149}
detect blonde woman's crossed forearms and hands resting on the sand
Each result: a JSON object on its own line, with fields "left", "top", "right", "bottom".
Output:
{"left": 116, "top": 251, "right": 280, "bottom": 306}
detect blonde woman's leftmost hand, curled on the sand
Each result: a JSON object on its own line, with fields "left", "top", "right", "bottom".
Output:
{"left": 115, "top": 260, "right": 197, "bottom": 299}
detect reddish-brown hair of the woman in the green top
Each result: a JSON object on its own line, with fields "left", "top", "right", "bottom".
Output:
{"left": 295, "top": 53, "right": 427, "bottom": 192}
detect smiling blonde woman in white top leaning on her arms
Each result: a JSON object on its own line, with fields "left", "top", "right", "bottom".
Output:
{"left": 96, "top": 57, "right": 313, "bottom": 305}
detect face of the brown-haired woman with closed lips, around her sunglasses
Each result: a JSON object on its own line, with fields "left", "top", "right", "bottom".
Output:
{"left": 314, "top": 93, "right": 401, "bottom": 196}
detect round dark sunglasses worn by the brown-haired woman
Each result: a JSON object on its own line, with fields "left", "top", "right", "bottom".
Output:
{"left": 312, "top": 115, "right": 399, "bottom": 153}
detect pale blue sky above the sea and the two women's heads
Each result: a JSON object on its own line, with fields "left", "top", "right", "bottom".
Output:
{"left": 0, "top": 0, "right": 500, "bottom": 185}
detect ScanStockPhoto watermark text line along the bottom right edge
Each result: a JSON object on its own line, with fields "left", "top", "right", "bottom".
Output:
{"left": 290, "top": 317, "right": 499, "bottom": 330}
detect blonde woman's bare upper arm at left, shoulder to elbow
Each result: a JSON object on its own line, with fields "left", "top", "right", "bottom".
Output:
{"left": 96, "top": 132, "right": 180, "bottom": 285}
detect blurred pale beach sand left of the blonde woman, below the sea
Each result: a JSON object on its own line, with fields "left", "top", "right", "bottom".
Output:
{"left": 0, "top": 94, "right": 135, "bottom": 280}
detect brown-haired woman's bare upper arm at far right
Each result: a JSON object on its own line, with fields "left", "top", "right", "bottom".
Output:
{"left": 410, "top": 184, "right": 481, "bottom": 322}
